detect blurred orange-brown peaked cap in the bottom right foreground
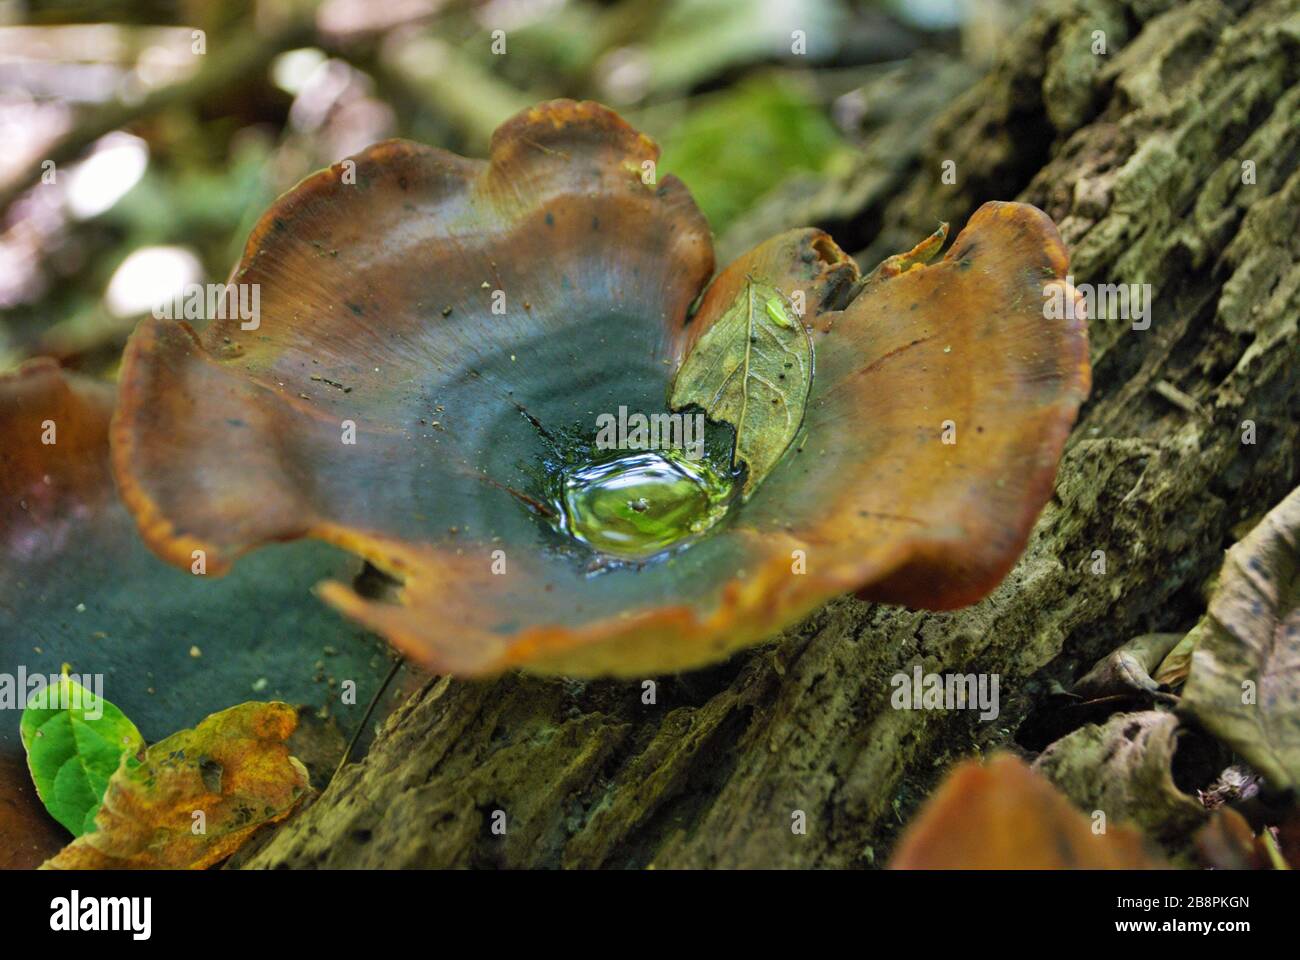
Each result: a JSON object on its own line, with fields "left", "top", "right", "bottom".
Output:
{"left": 889, "top": 754, "right": 1160, "bottom": 870}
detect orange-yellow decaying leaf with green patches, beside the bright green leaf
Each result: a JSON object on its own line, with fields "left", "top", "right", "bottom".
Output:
{"left": 44, "top": 702, "right": 307, "bottom": 869}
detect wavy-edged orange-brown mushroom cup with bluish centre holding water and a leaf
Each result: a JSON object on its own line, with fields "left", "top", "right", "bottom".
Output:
{"left": 113, "top": 101, "right": 1088, "bottom": 675}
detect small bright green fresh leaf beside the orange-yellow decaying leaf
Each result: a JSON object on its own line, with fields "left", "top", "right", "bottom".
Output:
{"left": 20, "top": 674, "right": 144, "bottom": 836}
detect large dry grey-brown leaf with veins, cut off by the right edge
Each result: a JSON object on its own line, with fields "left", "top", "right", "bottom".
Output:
{"left": 1182, "top": 488, "right": 1300, "bottom": 791}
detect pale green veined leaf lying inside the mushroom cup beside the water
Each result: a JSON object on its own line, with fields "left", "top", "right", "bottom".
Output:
{"left": 671, "top": 277, "right": 813, "bottom": 498}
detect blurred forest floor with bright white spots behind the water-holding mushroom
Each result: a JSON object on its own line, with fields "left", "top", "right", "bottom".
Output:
{"left": 0, "top": 0, "right": 977, "bottom": 376}
